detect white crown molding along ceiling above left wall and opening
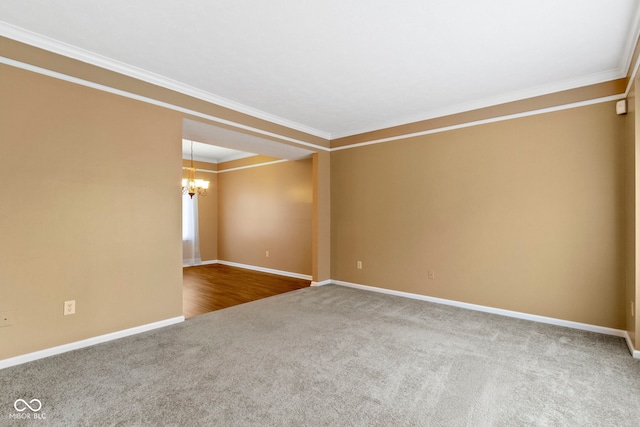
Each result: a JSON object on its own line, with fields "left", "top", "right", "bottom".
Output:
{"left": 0, "top": 21, "right": 330, "bottom": 139}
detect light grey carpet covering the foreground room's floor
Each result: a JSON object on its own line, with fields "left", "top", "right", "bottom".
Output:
{"left": 0, "top": 285, "right": 640, "bottom": 426}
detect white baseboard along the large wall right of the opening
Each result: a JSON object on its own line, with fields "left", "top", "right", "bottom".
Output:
{"left": 330, "top": 280, "right": 640, "bottom": 359}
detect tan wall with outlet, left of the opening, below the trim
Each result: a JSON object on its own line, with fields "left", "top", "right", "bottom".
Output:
{"left": 0, "top": 65, "right": 182, "bottom": 359}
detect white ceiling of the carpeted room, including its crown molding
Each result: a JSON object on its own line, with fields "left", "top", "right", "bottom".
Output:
{"left": 0, "top": 0, "right": 640, "bottom": 138}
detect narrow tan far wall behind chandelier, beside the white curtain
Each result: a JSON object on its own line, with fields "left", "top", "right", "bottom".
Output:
{"left": 182, "top": 160, "right": 218, "bottom": 261}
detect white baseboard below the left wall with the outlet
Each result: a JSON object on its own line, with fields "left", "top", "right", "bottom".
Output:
{"left": 0, "top": 316, "right": 184, "bottom": 369}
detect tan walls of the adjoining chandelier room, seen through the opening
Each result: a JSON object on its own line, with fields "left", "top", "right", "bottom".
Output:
{"left": 182, "top": 156, "right": 312, "bottom": 270}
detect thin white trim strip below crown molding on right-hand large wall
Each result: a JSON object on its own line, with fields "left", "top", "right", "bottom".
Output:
{"left": 331, "top": 94, "right": 626, "bottom": 151}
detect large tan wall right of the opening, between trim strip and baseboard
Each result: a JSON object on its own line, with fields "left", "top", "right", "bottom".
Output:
{"left": 331, "top": 102, "right": 625, "bottom": 329}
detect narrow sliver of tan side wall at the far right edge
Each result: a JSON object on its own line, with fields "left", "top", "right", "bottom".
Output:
{"left": 623, "top": 78, "right": 640, "bottom": 348}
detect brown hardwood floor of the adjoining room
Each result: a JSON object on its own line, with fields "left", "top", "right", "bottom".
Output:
{"left": 182, "top": 264, "right": 311, "bottom": 319}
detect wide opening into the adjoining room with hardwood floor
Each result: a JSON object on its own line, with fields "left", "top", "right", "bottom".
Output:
{"left": 183, "top": 120, "right": 313, "bottom": 318}
